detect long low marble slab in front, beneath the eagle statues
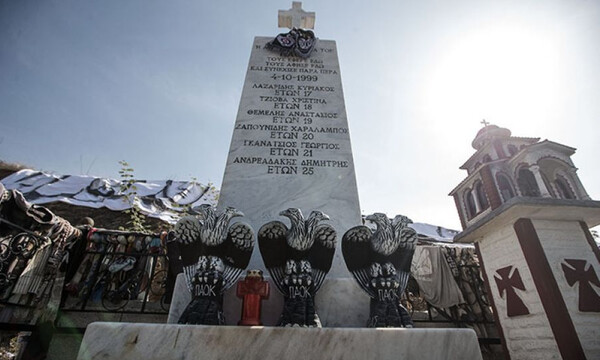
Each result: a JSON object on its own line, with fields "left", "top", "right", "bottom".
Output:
{"left": 77, "top": 322, "right": 482, "bottom": 360}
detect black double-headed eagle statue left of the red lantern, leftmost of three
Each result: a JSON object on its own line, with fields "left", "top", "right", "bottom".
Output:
{"left": 175, "top": 205, "right": 254, "bottom": 325}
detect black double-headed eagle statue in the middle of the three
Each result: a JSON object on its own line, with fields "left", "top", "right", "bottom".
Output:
{"left": 258, "top": 208, "right": 336, "bottom": 327}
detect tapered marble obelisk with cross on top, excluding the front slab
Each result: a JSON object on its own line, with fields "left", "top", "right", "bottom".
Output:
{"left": 218, "top": 2, "right": 368, "bottom": 326}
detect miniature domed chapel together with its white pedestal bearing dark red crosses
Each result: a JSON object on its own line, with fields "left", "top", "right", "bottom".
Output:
{"left": 450, "top": 122, "right": 600, "bottom": 359}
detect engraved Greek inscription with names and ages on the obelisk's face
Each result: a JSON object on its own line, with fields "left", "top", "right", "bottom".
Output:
{"left": 231, "top": 38, "right": 351, "bottom": 176}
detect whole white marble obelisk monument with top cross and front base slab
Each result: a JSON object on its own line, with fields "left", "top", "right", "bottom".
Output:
{"left": 78, "top": 3, "right": 481, "bottom": 360}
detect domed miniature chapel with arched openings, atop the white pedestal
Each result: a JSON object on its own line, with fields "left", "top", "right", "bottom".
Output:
{"left": 450, "top": 122, "right": 590, "bottom": 230}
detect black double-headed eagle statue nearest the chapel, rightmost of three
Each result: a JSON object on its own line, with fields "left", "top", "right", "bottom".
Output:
{"left": 342, "top": 213, "right": 417, "bottom": 327}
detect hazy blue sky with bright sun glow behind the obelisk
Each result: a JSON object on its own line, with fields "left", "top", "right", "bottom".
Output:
{"left": 0, "top": 0, "right": 600, "bottom": 229}
